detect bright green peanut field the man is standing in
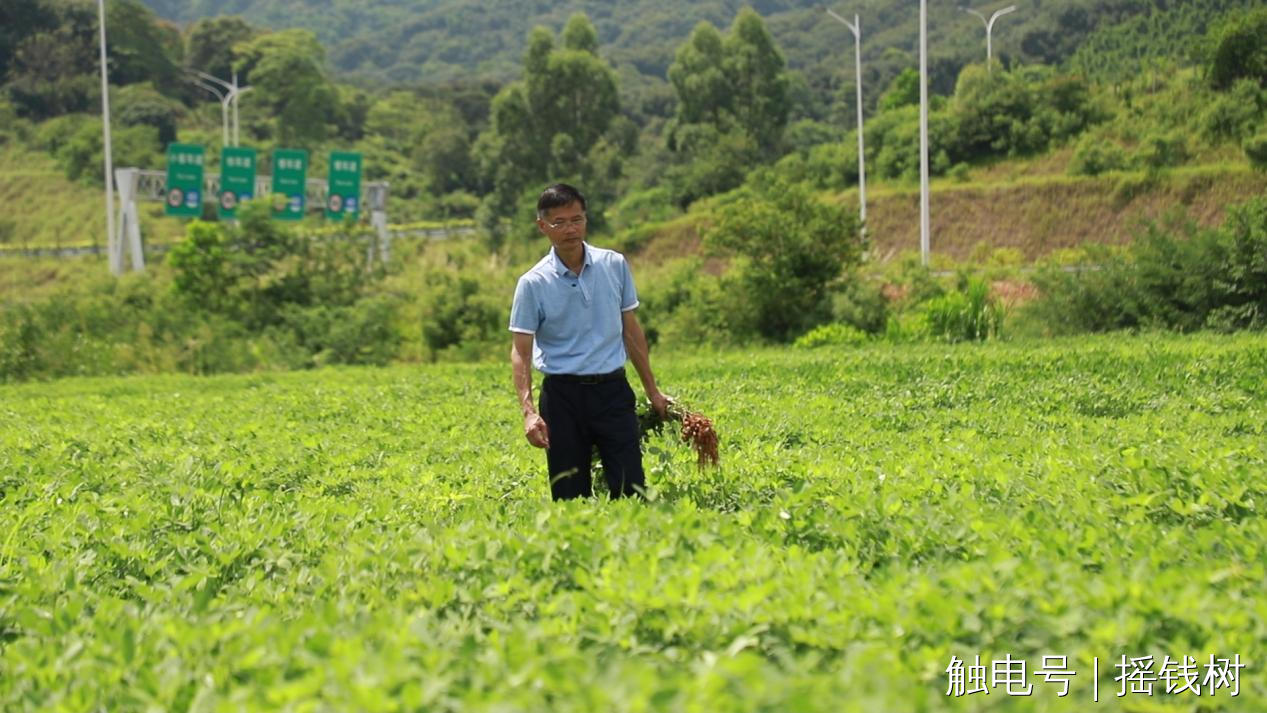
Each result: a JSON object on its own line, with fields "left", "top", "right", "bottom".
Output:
{"left": 0, "top": 336, "right": 1267, "bottom": 713}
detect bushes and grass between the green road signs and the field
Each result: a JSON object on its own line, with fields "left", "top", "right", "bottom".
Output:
{"left": 0, "top": 200, "right": 402, "bottom": 381}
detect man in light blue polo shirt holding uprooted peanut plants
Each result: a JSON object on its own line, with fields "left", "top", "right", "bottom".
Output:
{"left": 511, "top": 184, "right": 669, "bottom": 500}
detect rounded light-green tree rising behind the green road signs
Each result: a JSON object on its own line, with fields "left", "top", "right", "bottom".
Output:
{"left": 233, "top": 29, "right": 338, "bottom": 146}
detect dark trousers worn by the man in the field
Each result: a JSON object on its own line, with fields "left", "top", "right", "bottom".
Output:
{"left": 538, "top": 370, "right": 646, "bottom": 500}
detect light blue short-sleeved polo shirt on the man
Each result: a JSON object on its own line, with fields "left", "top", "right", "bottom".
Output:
{"left": 511, "top": 243, "right": 639, "bottom": 374}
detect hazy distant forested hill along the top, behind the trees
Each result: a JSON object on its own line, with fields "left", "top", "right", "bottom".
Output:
{"left": 138, "top": 0, "right": 1244, "bottom": 92}
